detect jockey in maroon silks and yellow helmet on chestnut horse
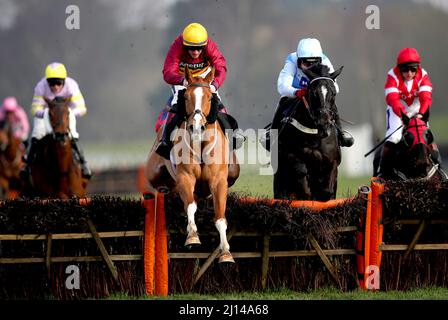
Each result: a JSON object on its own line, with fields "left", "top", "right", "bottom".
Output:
{"left": 156, "top": 23, "right": 242, "bottom": 159}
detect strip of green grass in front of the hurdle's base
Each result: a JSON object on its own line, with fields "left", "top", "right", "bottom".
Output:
{"left": 108, "top": 287, "right": 448, "bottom": 300}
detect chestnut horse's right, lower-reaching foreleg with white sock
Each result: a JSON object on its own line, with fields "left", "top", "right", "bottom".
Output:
{"left": 210, "top": 178, "right": 235, "bottom": 262}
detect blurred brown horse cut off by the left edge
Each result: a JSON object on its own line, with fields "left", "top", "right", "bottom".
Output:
{"left": 0, "top": 113, "right": 25, "bottom": 199}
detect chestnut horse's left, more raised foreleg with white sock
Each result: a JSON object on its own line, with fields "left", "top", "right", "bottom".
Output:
{"left": 177, "top": 174, "right": 201, "bottom": 246}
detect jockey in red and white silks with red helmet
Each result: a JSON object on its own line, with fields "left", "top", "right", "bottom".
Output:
{"left": 379, "top": 48, "right": 442, "bottom": 176}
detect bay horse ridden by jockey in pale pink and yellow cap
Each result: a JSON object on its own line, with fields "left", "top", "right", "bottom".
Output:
{"left": 25, "top": 97, "right": 87, "bottom": 199}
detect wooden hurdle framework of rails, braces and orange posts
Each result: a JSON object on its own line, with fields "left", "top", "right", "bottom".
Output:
{"left": 0, "top": 178, "right": 448, "bottom": 296}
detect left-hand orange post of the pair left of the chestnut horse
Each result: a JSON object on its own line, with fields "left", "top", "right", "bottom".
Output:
{"left": 143, "top": 192, "right": 156, "bottom": 296}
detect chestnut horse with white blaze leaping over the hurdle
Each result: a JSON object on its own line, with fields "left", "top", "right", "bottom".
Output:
{"left": 146, "top": 67, "right": 239, "bottom": 262}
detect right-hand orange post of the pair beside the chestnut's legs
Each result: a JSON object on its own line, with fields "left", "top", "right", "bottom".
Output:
{"left": 155, "top": 192, "right": 168, "bottom": 296}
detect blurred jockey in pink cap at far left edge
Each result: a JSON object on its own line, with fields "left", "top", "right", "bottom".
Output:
{"left": 0, "top": 97, "right": 30, "bottom": 144}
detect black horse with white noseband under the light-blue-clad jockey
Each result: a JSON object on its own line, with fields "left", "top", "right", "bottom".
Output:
{"left": 271, "top": 64, "right": 342, "bottom": 201}
